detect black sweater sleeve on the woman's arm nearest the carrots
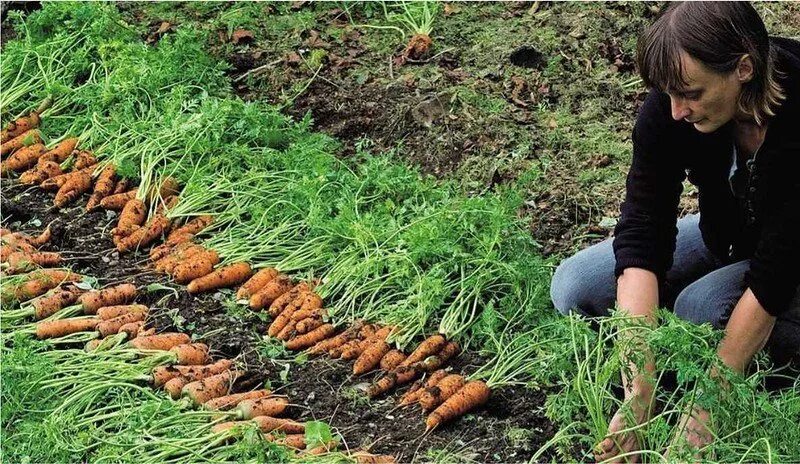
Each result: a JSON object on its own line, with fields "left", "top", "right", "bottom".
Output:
{"left": 614, "top": 90, "right": 686, "bottom": 280}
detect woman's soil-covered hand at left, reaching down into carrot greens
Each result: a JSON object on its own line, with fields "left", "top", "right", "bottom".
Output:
{"left": 594, "top": 396, "right": 650, "bottom": 463}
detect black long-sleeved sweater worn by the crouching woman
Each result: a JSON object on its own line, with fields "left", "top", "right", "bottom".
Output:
{"left": 614, "top": 38, "right": 800, "bottom": 316}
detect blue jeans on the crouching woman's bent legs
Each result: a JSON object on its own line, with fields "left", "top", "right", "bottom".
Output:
{"left": 550, "top": 214, "right": 800, "bottom": 364}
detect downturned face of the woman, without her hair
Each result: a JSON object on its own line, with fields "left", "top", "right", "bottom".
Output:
{"left": 667, "top": 52, "right": 753, "bottom": 133}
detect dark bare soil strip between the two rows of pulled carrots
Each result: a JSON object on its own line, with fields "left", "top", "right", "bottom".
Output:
{"left": 0, "top": 179, "right": 556, "bottom": 462}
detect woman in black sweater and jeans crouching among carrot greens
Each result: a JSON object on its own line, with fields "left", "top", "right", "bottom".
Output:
{"left": 551, "top": 2, "right": 800, "bottom": 461}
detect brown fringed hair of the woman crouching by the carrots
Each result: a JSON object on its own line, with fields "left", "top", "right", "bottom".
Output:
{"left": 636, "top": 2, "right": 786, "bottom": 124}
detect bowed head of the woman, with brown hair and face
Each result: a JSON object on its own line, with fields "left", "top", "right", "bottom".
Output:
{"left": 636, "top": 2, "right": 784, "bottom": 132}
